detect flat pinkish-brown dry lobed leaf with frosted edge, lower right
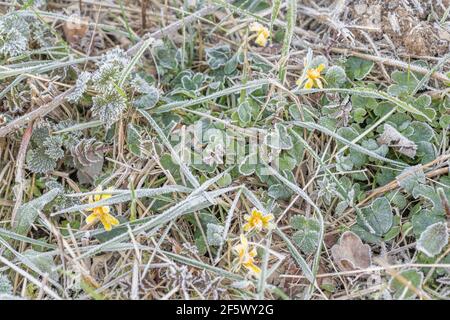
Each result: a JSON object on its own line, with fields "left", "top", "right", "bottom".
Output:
{"left": 331, "top": 231, "right": 372, "bottom": 271}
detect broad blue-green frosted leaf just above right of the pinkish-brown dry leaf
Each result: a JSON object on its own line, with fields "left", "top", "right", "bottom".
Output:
{"left": 357, "top": 197, "right": 393, "bottom": 237}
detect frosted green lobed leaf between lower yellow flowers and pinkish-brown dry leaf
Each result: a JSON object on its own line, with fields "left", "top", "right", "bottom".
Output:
{"left": 290, "top": 215, "right": 320, "bottom": 253}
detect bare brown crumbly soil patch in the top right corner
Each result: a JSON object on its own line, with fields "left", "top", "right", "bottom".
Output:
{"left": 345, "top": 0, "right": 450, "bottom": 56}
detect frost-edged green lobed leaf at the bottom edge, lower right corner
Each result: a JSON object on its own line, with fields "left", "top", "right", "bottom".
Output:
{"left": 389, "top": 269, "right": 423, "bottom": 300}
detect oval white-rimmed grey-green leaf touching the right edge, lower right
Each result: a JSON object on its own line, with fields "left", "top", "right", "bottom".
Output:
{"left": 417, "top": 222, "right": 448, "bottom": 257}
